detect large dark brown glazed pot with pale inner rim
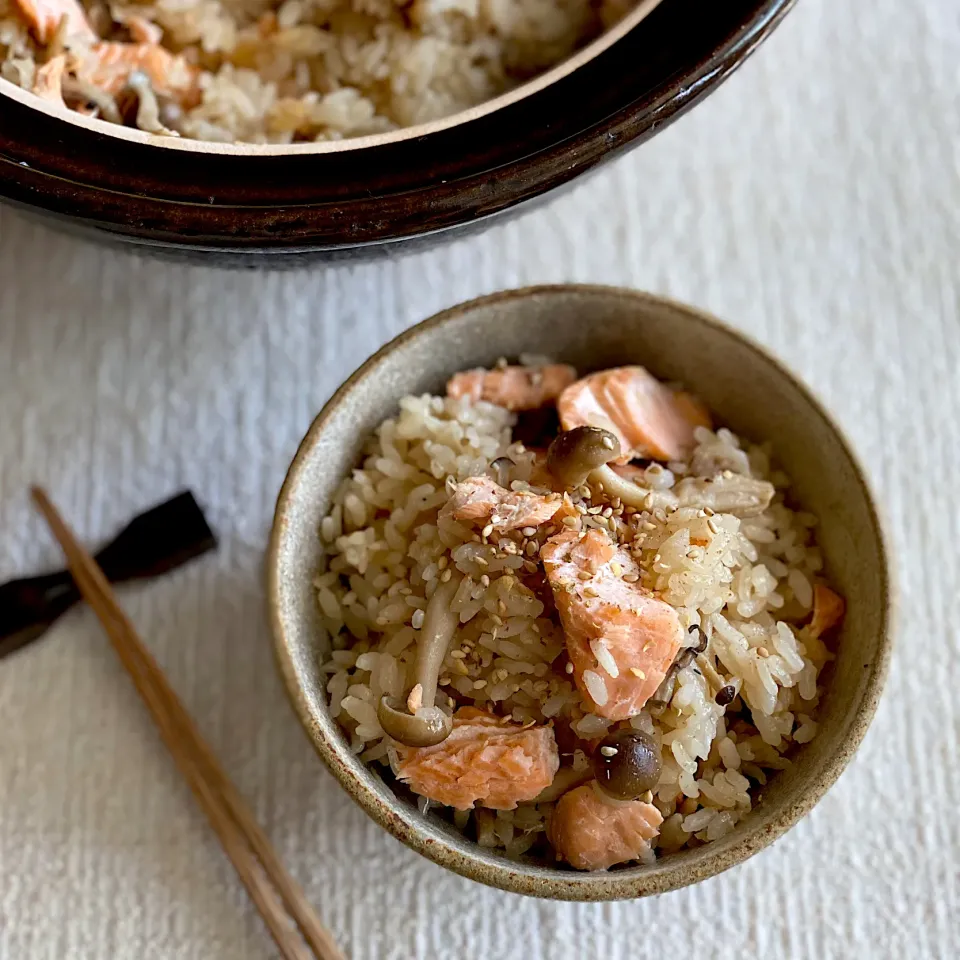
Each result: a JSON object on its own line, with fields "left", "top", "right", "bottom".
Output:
{"left": 0, "top": 0, "right": 794, "bottom": 265}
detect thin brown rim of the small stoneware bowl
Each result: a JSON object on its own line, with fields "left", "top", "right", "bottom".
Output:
{"left": 265, "top": 283, "right": 897, "bottom": 902}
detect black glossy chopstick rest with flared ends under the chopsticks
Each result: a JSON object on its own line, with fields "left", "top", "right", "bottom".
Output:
{"left": 0, "top": 491, "right": 217, "bottom": 657}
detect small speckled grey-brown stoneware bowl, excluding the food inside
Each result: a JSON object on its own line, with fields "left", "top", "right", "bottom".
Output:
{"left": 267, "top": 286, "right": 891, "bottom": 900}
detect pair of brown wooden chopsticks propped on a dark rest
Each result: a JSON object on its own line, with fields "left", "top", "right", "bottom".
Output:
{"left": 32, "top": 487, "right": 344, "bottom": 960}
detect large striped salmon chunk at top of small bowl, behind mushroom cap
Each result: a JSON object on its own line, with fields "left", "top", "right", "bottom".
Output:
{"left": 557, "top": 367, "right": 710, "bottom": 463}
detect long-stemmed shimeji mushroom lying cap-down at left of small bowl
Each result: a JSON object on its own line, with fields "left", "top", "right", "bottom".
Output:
{"left": 377, "top": 576, "right": 462, "bottom": 747}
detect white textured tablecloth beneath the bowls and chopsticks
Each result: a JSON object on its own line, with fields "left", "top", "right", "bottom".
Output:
{"left": 0, "top": 0, "right": 960, "bottom": 960}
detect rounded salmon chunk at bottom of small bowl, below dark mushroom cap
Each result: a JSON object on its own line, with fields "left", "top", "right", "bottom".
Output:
{"left": 548, "top": 783, "right": 663, "bottom": 870}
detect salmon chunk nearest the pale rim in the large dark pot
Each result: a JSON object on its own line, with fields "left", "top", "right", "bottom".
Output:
{"left": 78, "top": 41, "right": 201, "bottom": 109}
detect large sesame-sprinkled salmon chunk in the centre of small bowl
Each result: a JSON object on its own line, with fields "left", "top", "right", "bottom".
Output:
{"left": 540, "top": 529, "right": 683, "bottom": 720}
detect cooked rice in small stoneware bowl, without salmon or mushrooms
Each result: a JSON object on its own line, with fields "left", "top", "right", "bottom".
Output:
{"left": 316, "top": 388, "right": 832, "bottom": 857}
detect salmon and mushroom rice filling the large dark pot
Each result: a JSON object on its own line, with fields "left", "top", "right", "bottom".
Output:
{"left": 0, "top": 0, "right": 636, "bottom": 143}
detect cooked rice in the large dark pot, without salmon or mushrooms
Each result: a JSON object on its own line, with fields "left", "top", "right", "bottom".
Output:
{"left": 0, "top": 0, "right": 635, "bottom": 143}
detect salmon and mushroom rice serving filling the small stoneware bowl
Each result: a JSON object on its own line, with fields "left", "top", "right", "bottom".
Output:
{"left": 315, "top": 357, "right": 844, "bottom": 870}
